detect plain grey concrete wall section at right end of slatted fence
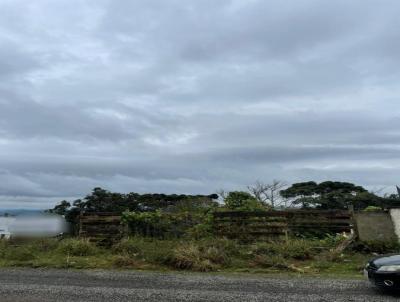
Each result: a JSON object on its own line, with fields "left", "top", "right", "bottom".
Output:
{"left": 354, "top": 212, "right": 400, "bottom": 241}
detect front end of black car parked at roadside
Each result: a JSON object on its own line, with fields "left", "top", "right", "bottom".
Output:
{"left": 364, "top": 254, "right": 400, "bottom": 290}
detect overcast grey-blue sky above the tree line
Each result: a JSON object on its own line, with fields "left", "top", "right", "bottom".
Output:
{"left": 0, "top": 0, "right": 400, "bottom": 208}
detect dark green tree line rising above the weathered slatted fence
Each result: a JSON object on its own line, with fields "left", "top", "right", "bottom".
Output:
{"left": 47, "top": 180, "right": 400, "bottom": 221}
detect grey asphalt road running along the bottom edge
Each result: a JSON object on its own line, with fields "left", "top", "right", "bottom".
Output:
{"left": 0, "top": 269, "right": 400, "bottom": 302}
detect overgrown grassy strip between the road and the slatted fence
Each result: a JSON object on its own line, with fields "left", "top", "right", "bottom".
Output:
{"left": 0, "top": 237, "right": 397, "bottom": 276}
